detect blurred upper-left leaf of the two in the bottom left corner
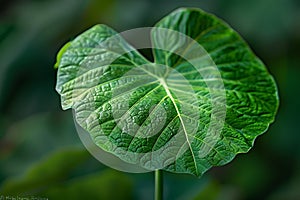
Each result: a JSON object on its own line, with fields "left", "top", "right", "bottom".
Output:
{"left": 0, "top": 148, "right": 89, "bottom": 195}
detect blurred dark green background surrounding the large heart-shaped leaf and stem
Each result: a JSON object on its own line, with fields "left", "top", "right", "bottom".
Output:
{"left": 0, "top": 0, "right": 300, "bottom": 200}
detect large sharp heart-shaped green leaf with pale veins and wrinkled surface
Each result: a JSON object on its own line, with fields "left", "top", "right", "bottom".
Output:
{"left": 56, "top": 8, "right": 278, "bottom": 176}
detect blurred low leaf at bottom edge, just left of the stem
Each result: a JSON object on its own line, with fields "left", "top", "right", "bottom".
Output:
{"left": 43, "top": 169, "right": 133, "bottom": 200}
